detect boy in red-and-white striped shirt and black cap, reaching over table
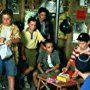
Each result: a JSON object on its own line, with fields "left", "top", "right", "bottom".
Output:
{"left": 62, "top": 33, "right": 90, "bottom": 77}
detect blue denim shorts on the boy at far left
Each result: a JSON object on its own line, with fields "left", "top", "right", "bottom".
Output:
{"left": 0, "top": 58, "right": 17, "bottom": 76}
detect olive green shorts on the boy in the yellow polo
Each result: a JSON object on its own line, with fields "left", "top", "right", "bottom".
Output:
{"left": 25, "top": 48, "right": 37, "bottom": 67}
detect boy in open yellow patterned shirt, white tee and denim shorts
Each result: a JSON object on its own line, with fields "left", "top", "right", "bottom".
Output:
{"left": 0, "top": 9, "right": 20, "bottom": 90}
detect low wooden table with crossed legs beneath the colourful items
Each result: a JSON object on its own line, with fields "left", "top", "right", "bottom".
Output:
{"left": 37, "top": 75, "right": 83, "bottom": 90}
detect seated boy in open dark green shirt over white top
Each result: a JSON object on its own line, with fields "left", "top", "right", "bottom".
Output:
{"left": 33, "top": 39, "right": 60, "bottom": 85}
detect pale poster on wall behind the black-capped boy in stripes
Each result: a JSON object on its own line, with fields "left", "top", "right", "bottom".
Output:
{"left": 73, "top": 22, "right": 87, "bottom": 43}
